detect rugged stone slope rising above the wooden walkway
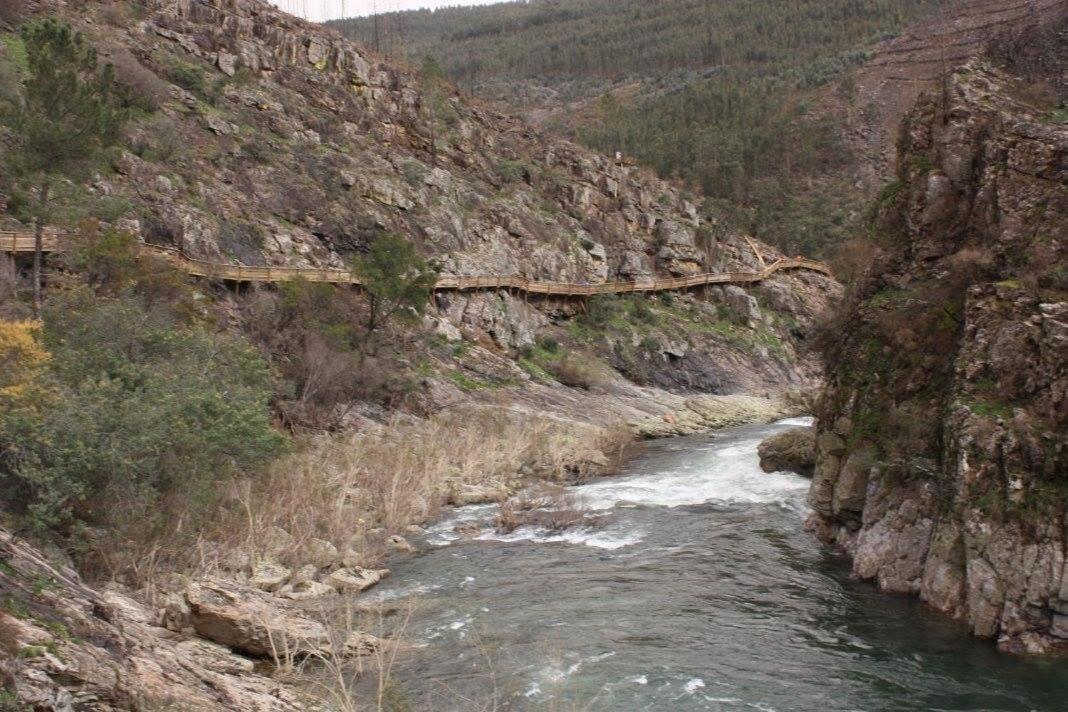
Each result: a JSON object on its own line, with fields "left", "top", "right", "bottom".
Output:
{"left": 112, "top": 0, "right": 803, "bottom": 282}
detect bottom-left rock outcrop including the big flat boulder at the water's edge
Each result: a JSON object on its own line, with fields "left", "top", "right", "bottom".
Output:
{"left": 0, "top": 529, "right": 392, "bottom": 712}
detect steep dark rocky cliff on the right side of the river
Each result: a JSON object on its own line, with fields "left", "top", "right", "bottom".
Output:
{"left": 810, "top": 58, "right": 1068, "bottom": 652}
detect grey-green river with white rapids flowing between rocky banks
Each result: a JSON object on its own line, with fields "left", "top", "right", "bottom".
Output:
{"left": 360, "top": 421, "right": 1068, "bottom": 712}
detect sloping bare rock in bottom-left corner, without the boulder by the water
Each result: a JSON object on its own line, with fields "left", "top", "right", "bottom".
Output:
{"left": 0, "top": 531, "right": 312, "bottom": 712}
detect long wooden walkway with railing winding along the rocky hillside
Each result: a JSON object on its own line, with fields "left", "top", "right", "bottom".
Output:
{"left": 0, "top": 231, "right": 831, "bottom": 297}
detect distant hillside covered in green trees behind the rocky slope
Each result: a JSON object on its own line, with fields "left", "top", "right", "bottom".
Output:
{"left": 335, "top": 0, "right": 945, "bottom": 254}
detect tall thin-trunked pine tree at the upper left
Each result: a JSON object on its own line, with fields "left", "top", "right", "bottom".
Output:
{"left": 2, "top": 17, "right": 121, "bottom": 315}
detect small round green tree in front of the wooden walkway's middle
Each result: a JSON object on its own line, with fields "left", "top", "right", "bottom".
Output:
{"left": 352, "top": 233, "right": 438, "bottom": 336}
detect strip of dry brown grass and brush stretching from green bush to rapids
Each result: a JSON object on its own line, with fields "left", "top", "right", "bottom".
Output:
{"left": 83, "top": 407, "right": 633, "bottom": 597}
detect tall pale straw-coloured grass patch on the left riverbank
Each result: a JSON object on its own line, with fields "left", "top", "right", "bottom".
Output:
{"left": 221, "top": 407, "right": 631, "bottom": 567}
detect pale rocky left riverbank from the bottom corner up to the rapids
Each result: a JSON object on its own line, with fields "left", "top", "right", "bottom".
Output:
{"left": 0, "top": 391, "right": 796, "bottom": 712}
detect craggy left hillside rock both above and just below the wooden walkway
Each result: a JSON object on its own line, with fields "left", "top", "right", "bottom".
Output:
{"left": 2, "top": 0, "right": 835, "bottom": 393}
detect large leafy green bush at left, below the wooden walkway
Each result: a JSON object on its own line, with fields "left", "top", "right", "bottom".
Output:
{"left": 0, "top": 290, "right": 285, "bottom": 532}
